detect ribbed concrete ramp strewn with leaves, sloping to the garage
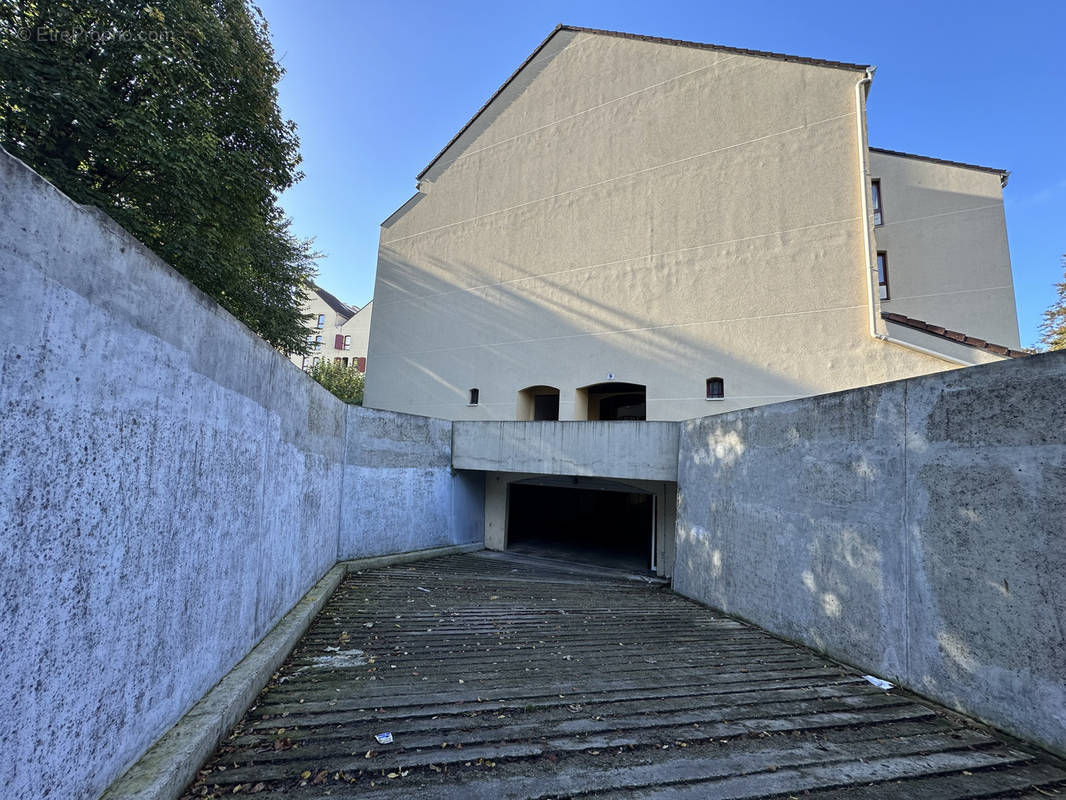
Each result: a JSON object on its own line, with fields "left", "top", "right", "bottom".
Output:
{"left": 179, "top": 554, "right": 1066, "bottom": 800}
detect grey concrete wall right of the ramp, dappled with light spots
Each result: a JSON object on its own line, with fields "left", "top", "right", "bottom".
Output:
{"left": 674, "top": 353, "right": 1066, "bottom": 753}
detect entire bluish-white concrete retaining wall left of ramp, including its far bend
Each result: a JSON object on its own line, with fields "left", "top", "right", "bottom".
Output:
{"left": 0, "top": 150, "right": 480, "bottom": 800}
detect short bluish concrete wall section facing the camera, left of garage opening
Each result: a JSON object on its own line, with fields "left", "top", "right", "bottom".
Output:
{"left": 339, "top": 406, "right": 485, "bottom": 559}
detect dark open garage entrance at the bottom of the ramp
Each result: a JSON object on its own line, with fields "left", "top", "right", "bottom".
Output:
{"left": 507, "top": 479, "right": 656, "bottom": 572}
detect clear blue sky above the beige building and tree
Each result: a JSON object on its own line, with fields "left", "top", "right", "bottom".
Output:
{"left": 259, "top": 0, "right": 1066, "bottom": 346}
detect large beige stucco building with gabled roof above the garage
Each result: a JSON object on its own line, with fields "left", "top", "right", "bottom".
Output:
{"left": 365, "top": 27, "right": 1020, "bottom": 419}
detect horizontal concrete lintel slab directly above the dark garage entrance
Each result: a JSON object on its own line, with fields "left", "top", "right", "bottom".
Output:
{"left": 452, "top": 421, "right": 679, "bottom": 481}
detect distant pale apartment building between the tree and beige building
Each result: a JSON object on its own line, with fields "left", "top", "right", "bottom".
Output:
{"left": 289, "top": 286, "right": 374, "bottom": 372}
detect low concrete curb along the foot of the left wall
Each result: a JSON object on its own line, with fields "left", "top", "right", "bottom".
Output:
{"left": 100, "top": 544, "right": 482, "bottom": 800}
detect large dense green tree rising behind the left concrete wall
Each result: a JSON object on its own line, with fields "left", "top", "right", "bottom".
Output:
{"left": 0, "top": 0, "right": 316, "bottom": 353}
